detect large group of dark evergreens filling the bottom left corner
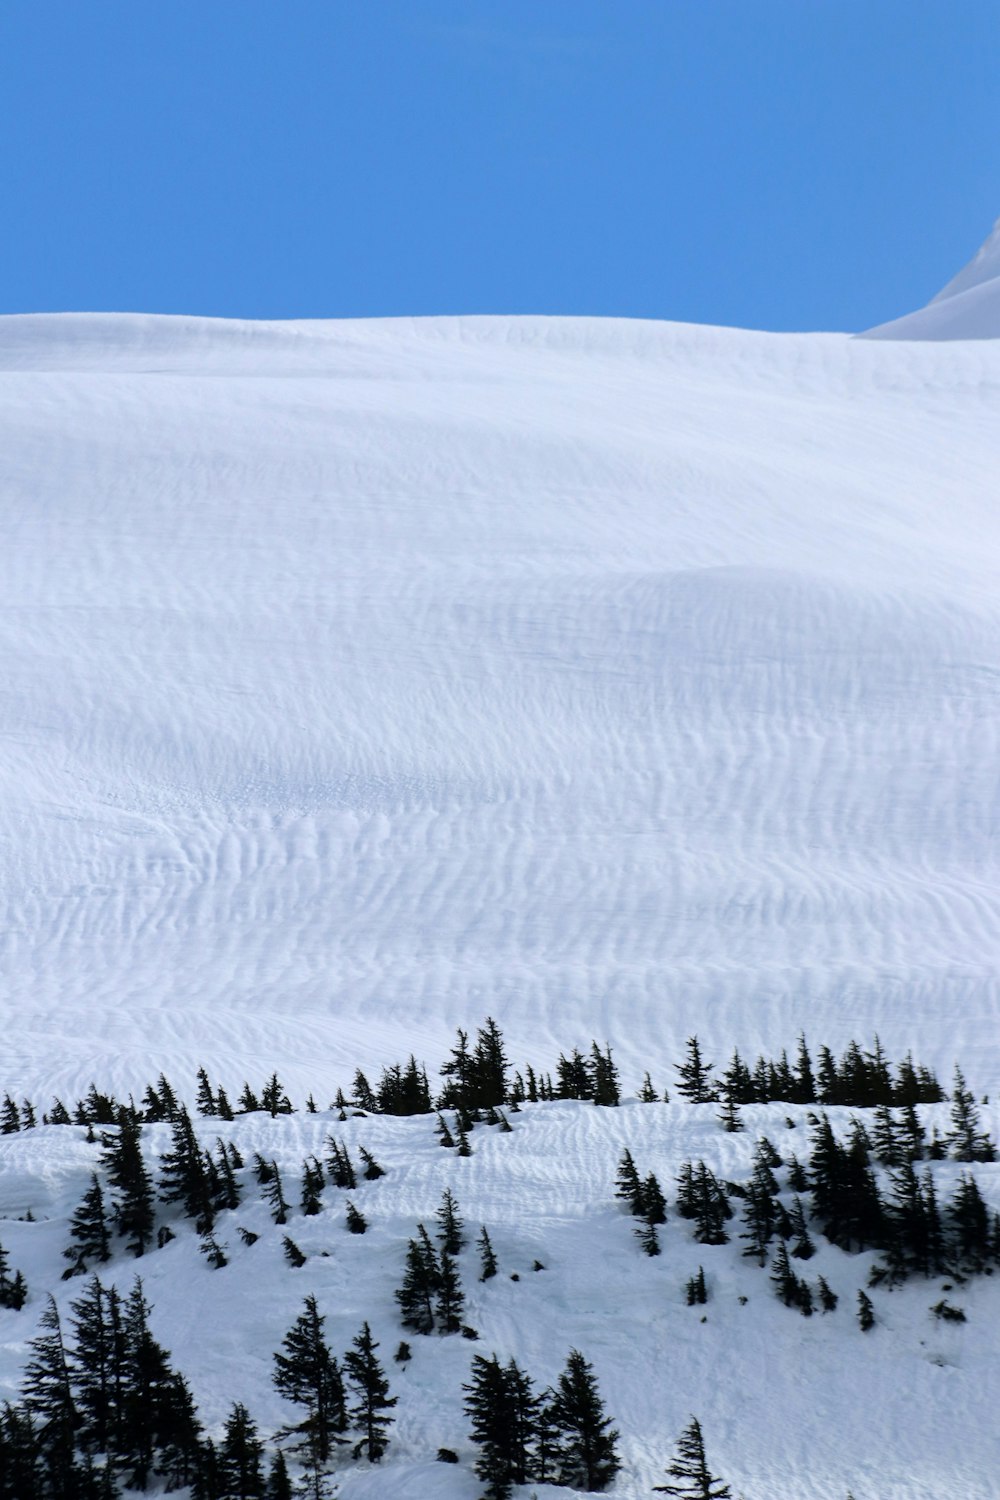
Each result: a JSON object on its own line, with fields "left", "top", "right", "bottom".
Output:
{"left": 0, "top": 1277, "right": 396, "bottom": 1500}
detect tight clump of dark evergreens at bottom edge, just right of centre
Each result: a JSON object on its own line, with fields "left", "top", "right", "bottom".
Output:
{"left": 462, "top": 1349, "right": 621, "bottom": 1500}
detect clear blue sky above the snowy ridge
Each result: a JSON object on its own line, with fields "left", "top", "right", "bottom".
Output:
{"left": 0, "top": 0, "right": 1000, "bottom": 329}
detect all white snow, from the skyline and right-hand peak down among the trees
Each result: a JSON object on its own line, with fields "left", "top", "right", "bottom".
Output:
{"left": 0, "top": 225, "right": 1000, "bottom": 1500}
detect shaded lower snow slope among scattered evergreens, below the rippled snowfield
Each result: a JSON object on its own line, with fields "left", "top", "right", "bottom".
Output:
{"left": 0, "top": 1080, "right": 1000, "bottom": 1500}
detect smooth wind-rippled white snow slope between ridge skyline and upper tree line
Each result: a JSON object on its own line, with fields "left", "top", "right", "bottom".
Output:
{"left": 0, "top": 315, "right": 1000, "bottom": 1104}
